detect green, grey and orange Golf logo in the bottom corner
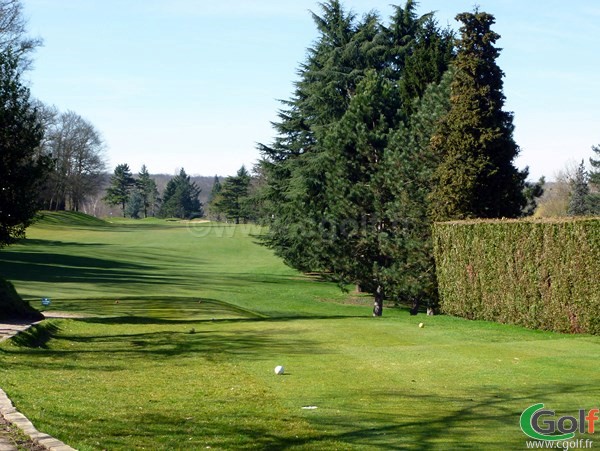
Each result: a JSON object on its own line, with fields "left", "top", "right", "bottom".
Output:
{"left": 520, "top": 403, "right": 600, "bottom": 442}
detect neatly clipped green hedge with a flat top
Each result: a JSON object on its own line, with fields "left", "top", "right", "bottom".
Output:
{"left": 433, "top": 218, "right": 600, "bottom": 334}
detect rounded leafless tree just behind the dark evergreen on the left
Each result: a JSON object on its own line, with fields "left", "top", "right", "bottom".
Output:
{"left": 43, "top": 111, "right": 106, "bottom": 211}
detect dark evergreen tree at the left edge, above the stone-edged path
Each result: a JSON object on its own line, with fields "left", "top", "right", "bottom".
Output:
{"left": 0, "top": 50, "right": 50, "bottom": 248}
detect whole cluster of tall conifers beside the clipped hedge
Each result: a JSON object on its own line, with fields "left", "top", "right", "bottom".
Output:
{"left": 253, "top": 0, "right": 541, "bottom": 315}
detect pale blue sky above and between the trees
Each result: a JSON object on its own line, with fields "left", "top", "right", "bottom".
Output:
{"left": 22, "top": 0, "right": 600, "bottom": 180}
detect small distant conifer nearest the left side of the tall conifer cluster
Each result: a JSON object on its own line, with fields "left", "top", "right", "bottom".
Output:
{"left": 214, "top": 166, "right": 251, "bottom": 224}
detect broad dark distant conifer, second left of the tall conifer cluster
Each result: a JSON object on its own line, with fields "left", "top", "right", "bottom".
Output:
{"left": 159, "top": 169, "right": 203, "bottom": 219}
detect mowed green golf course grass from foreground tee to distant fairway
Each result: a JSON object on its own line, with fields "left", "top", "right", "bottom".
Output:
{"left": 0, "top": 214, "right": 600, "bottom": 450}
